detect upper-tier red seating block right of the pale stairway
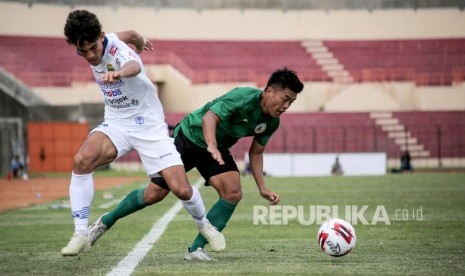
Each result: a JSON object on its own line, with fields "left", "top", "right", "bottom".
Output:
{"left": 324, "top": 38, "right": 465, "bottom": 85}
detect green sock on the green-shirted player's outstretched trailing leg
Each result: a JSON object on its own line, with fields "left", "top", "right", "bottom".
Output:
{"left": 102, "top": 188, "right": 147, "bottom": 229}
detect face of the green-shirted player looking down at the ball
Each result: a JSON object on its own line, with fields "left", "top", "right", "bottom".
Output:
{"left": 263, "top": 86, "right": 297, "bottom": 118}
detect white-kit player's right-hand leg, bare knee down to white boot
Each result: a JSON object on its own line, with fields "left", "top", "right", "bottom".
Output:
{"left": 161, "top": 166, "right": 226, "bottom": 252}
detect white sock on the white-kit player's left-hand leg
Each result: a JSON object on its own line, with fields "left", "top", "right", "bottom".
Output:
{"left": 69, "top": 172, "right": 94, "bottom": 236}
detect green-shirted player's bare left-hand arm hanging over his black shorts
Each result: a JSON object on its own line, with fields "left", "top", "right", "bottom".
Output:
{"left": 202, "top": 110, "right": 224, "bottom": 165}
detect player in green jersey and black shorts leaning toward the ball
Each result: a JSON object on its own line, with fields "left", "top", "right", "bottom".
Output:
{"left": 89, "top": 67, "right": 304, "bottom": 261}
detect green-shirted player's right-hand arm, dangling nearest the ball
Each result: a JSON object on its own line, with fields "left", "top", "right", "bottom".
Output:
{"left": 249, "top": 139, "right": 280, "bottom": 205}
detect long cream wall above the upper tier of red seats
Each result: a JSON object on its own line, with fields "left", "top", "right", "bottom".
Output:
{"left": 0, "top": 2, "right": 465, "bottom": 40}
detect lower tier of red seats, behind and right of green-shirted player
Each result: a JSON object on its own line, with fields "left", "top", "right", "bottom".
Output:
{"left": 228, "top": 111, "right": 465, "bottom": 159}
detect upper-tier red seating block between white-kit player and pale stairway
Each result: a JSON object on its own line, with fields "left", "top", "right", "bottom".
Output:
{"left": 146, "top": 40, "right": 329, "bottom": 83}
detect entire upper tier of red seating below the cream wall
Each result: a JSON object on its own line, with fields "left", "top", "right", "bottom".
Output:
{"left": 0, "top": 35, "right": 465, "bottom": 86}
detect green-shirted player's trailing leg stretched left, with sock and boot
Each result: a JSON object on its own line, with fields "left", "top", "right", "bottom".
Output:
{"left": 89, "top": 182, "right": 169, "bottom": 246}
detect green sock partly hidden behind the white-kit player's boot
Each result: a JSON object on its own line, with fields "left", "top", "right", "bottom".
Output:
{"left": 189, "top": 198, "right": 236, "bottom": 252}
